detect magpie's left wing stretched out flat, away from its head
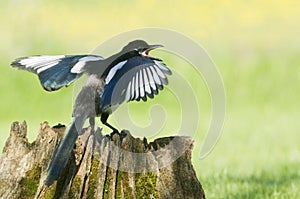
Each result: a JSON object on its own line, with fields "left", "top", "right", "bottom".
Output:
{"left": 11, "top": 55, "right": 103, "bottom": 91}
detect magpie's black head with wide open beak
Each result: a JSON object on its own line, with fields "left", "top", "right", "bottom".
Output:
{"left": 122, "top": 40, "right": 163, "bottom": 61}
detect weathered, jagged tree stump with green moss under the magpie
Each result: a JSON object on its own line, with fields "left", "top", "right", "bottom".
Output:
{"left": 0, "top": 122, "right": 205, "bottom": 199}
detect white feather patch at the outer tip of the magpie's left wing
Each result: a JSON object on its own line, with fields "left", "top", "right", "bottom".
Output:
{"left": 19, "top": 55, "right": 65, "bottom": 73}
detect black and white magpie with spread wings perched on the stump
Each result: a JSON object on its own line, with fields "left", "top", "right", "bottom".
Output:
{"left": 11, "top": 40, "right": 172, "bottom": 186}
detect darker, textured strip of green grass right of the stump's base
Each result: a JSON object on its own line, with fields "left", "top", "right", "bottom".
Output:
{"left": 201, "top": 164, "right": 300, "bottom": 199}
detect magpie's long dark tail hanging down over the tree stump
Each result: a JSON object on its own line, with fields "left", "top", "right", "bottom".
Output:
{"left": 45, "top": 116, "right": 86, "bottom": 186}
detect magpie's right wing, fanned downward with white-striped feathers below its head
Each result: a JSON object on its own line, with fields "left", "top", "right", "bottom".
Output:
{"left": 101, "top": 56, "right": 172, "bottom": 110}
